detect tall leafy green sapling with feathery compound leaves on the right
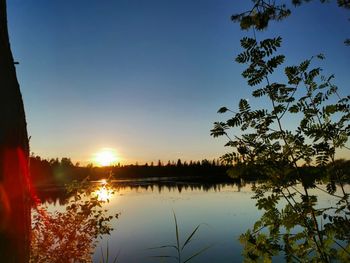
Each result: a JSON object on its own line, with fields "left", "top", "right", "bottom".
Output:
{"left": 211, "top": 18, "right": 350, "bottom": 262}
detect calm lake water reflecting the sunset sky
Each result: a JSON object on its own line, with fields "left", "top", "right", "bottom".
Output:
{"left": 35, "top": 182, "right": 344, "bottom": 263}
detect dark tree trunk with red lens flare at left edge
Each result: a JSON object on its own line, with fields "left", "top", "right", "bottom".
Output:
{"left": 0, "top": 0, "right": 31, "bottom": 262}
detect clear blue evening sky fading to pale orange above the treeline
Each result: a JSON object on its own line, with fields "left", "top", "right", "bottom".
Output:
{"left": 7, "top": 0, "right": 350, "bottom": 164}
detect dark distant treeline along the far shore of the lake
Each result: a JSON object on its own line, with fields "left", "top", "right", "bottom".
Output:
{"left": 30, "top": 156, "right": 350, "bottom": 186}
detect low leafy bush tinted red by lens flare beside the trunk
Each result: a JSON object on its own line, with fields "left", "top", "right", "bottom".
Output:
{"left": 30, "top": 178, "right": 118, "bottom": 263}
